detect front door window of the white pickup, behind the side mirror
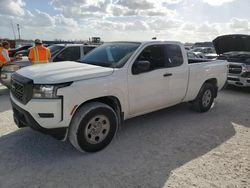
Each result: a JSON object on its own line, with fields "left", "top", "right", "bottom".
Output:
{"left": 136, "top": 45, "right": 165, "bottom": 71}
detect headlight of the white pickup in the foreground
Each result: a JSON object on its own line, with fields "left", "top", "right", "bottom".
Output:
{"left": 33, "top": 82, "right": 72, "bottom": 99}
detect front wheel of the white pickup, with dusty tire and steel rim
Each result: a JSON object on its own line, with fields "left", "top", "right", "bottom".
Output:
{"left": 69, "top": 102, "right": 118, "bottom": 152}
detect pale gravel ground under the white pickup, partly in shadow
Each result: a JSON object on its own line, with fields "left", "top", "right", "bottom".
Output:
{"left": 0, "top": 86, "right": 250, "bottom": 188}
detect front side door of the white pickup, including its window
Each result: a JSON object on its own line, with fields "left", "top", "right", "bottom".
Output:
{"left": 128, "top": 44, "right": 170, "bottom": 115}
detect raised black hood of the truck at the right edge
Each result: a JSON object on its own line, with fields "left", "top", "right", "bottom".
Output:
{"left": 213, "top": 34, "right": 250, "bottom": 54}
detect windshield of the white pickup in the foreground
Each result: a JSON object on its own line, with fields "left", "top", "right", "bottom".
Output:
{"left": 80, "top": 42, "right": 141, "bottom": 68}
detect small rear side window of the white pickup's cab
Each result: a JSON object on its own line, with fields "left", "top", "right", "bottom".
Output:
{"left": 165, "top": 44, "right": 183, "bottom": 67}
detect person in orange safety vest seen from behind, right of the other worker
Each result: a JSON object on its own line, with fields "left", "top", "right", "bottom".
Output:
{"left": 29, "top": 39, "right": 51, "bottom": 64}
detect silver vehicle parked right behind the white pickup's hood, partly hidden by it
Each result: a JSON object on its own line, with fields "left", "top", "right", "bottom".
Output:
{"left": 0, "top": 44, "right": 97, "bottom": 87}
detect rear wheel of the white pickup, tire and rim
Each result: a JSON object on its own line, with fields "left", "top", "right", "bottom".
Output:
{"left": 192, "top": 83, "right": 215, "bottom": 112}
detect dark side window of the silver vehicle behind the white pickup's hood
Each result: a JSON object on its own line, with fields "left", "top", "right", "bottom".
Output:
{"left": 54, "top": 46, "right": 80, "bottom": 61}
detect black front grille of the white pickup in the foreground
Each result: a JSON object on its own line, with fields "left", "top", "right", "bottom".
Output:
{"left": 11, "top": 73, "right": 33, "bottom": 104}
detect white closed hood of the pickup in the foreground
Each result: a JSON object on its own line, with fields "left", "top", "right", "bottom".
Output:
{"left": 17, "top": 61, "right": 113, "bottom": 84}
